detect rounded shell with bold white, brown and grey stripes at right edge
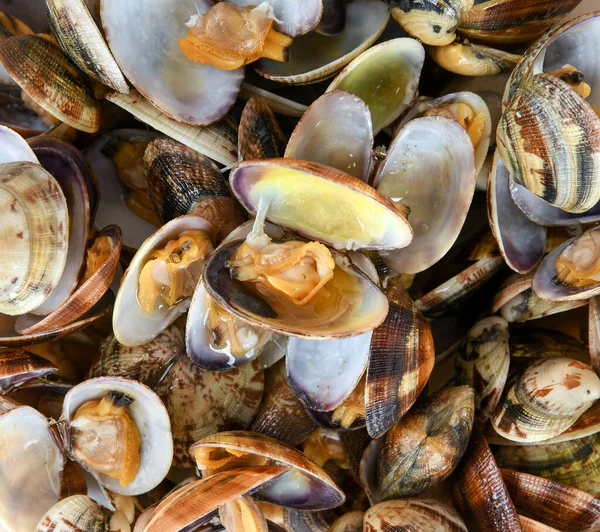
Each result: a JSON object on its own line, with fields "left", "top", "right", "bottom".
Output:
{"left": 497, "top": 74, "right": 600, "bottom": 213}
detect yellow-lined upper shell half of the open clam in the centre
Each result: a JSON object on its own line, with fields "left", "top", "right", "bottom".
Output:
{"left": 229, "top": 159, "right": 412, "bottom": 249}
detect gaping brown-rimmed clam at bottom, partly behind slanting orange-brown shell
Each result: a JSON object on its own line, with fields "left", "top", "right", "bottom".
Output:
{"left": 190, "top": 431, "right": 345, "bottom": 510}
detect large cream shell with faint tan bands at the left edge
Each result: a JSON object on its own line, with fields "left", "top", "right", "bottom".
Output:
{"left": 0, "top": 162, "right": 69, "bottom": 315}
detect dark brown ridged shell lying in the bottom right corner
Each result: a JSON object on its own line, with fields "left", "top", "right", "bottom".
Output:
{"left": 501, "top": 469, "right": 600, "bottom": 530}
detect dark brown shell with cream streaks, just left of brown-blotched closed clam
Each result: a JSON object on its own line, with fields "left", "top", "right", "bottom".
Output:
{"left": 456, "top": 316, "right": 510, "bottom": 421}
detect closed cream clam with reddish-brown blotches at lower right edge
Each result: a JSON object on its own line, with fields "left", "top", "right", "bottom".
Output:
{"left": 492, "top": 358, "right": 600, "bottom": 442}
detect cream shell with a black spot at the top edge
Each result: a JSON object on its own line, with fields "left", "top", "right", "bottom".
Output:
{"left": 388, "top": 0, "right": 473, "bottom": 46}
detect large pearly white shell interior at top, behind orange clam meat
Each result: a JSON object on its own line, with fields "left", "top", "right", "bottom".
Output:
{"left": 100, "top": 0, "right": 244, "bottom": 125}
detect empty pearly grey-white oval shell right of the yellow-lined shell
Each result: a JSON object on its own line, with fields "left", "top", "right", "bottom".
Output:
{"left": 374, "top": 116, "right": 477, "bottom": 273}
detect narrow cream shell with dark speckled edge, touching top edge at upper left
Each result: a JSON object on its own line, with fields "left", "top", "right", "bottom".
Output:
{"left": 46, "top": 0, "right": 129, "bottom": 92}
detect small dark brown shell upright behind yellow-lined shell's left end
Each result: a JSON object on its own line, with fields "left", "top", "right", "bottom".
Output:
{"left": 238, "top": 96, "right": 286, "bottom": 160}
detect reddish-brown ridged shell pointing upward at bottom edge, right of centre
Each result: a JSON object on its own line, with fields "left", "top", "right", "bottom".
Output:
{"left": 454, "top": 426, "right": 523, "bottom": 532}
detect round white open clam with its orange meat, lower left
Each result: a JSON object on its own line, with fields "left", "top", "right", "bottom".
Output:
{"left": 62, "top": 377, "right": 173, "bottom": 495}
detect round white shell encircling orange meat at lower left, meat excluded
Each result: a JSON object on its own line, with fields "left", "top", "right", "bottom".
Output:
{"left": 63, "top": 377, "right": 173, "bottom": 495}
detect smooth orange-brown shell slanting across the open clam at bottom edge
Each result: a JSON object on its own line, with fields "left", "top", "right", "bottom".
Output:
{"left": 144, "top": 466, "right": 288, "bottom": 532}
